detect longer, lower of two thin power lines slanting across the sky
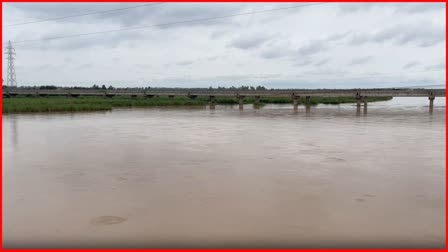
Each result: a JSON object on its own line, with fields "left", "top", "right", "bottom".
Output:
{"left": 3, "top": 3, "right": 327, "bottom": 44}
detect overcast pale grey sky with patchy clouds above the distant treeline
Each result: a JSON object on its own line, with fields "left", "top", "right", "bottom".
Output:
{"left": 2, "top": 3, "right": 446, "bottom": 88}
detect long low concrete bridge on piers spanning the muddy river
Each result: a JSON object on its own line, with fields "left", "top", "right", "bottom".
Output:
{"left": 2, "top": 88, "right": 445, "bottom": 111}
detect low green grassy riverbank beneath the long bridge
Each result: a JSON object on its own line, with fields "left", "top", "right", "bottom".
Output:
{"left": 2, "top": 96, "right": 392, "bottom": 114}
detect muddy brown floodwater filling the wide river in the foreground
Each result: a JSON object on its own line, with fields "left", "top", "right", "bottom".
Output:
{"left": 2, "top": 98, "right": 446, "bottom": 248}
